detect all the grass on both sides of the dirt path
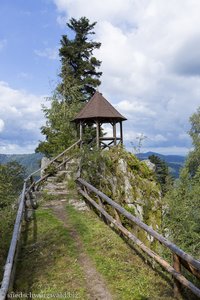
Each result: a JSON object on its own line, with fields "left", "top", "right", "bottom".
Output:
{"left": 14, "top": 193, "right": 173, "bottom": 300}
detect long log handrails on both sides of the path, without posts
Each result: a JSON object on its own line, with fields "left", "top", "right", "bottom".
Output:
{"left": 0, "top": 140, "right": 200, "bottom": 300}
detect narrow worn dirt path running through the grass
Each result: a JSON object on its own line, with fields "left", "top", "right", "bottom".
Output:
{"left": 51, "top": 203, "right": 113, "bottom": 300}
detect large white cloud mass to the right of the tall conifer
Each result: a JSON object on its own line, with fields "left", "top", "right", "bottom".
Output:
{"left": 54, "top": 0, "right": 200, "bottom": 152}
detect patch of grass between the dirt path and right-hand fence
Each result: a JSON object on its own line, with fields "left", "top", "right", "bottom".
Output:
{"left": 67, "top": 206, "right": 173, "bottom": 300}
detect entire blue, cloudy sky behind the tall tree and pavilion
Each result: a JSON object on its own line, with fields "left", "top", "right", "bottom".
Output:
{"left": 0, "top": 0, "right": 200, "bottom": 155}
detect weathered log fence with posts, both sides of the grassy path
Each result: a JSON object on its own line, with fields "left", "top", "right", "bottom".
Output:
{"left": 0, "top": 140, "right": 200, "bottom": 300}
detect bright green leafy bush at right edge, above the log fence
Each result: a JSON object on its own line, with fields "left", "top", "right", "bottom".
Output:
{"left": 164, "top": 168, "right": 200, "bottom": 258}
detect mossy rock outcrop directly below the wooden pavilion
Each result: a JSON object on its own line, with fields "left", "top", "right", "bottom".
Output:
{"left": 81, "top": 147, "right": 159, "bottom": 204}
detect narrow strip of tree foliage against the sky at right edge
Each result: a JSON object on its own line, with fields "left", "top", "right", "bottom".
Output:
{"left": 186, "top": 107, "right": 200, "bottom": 176}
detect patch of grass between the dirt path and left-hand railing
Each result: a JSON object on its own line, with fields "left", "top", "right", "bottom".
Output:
{"left": 14, "top": 209, "right": 87, "bottom": 299}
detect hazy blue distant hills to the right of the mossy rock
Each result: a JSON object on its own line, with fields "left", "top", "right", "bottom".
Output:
{"left": 137, "top": 152, "right": 186, "bottom": 178}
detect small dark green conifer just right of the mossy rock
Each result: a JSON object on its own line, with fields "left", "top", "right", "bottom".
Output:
{"left": 149, "top": 155, "right": 173, "bottom": 195}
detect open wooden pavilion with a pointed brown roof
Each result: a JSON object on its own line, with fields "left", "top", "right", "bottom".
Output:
{"left": 73, "top": 92, "right": 127, "bottom": 148}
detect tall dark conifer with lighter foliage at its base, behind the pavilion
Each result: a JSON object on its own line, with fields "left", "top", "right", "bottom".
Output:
{"left": 36, "top": 17, "right": 102, "bottom": 157}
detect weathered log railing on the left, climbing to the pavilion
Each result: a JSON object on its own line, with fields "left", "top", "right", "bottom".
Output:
{"left": 0, "top": 140, "right": 81, "bottom": 300}
